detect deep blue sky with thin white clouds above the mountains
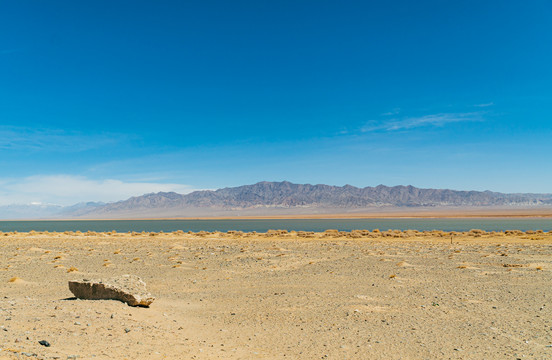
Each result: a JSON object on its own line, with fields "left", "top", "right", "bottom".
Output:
{"left": 0, "top": 0, "right": 552, "bottom": 204}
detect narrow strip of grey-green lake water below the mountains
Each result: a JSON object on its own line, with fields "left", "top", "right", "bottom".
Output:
{"left": 0, "top": 218, "right": 552, "bottom": 232}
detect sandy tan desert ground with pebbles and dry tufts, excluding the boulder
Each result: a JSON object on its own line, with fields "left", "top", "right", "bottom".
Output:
{"left": 0, "top": 231, "right": 552, "bottom": 359}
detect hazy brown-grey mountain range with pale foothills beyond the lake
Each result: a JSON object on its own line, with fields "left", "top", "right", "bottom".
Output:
{"left": 0, "top": 181, "right": 552, "bottom": 219}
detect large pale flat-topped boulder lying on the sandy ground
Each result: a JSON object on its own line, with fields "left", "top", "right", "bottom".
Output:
{"left": 69, "top": 275, "right": 155, "bottom": 307}
